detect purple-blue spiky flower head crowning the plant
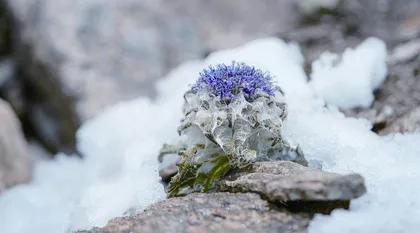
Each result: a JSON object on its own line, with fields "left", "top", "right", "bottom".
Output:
{"left": 191, "top": 61, "right": 281, "bottom": 101}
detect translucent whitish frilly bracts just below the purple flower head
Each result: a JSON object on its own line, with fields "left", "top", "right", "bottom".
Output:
{"left": 178, "top": 88, "right": 287, "bottom": 161}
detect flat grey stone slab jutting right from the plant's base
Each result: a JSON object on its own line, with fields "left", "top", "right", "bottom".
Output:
{"left": 219, "top": 161, "right": 366, "bottom": 202}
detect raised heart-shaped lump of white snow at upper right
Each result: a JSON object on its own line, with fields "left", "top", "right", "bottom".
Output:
{"left": 310, "top": 38, "right": 387, "bottom": 109}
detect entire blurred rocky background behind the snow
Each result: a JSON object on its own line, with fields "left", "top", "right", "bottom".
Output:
{"left": 0, "top": 0, "right": 420, "bottom": 190}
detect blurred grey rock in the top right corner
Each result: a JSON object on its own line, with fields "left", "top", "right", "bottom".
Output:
{"left": 294, "top": 0, "right": 420, "bottom": 43}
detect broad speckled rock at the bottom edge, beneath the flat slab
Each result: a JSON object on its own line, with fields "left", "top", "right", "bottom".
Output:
{"left": 79, "top": 193, "right": 310, "bottom": 233}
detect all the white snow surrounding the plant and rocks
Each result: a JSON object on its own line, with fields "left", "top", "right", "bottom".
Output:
{"left": 0, "top": 38, "right": 420, "bottom": 233}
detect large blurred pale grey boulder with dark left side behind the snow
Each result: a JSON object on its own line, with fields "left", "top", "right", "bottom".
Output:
{"left": 0, "top": 0, "right": 296, "bottom": 151}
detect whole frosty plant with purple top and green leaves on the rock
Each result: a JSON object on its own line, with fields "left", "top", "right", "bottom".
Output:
{"left": 161, "top": 62, "right": 306, "bottom": 197}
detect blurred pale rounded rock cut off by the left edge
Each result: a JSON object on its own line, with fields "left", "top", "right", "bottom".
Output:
{"left": 0, "top": 99, "right": 31, "bottom": 192}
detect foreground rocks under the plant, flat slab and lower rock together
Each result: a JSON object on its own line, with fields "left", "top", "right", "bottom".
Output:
{"left": 79, "top": 161, "right": 366, "bottom": 233}
